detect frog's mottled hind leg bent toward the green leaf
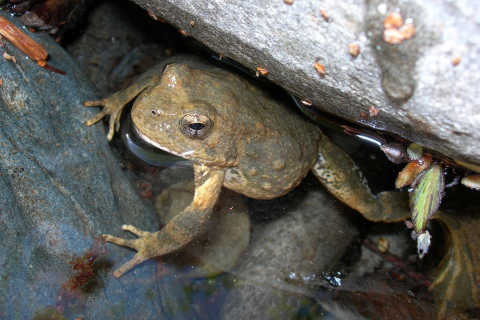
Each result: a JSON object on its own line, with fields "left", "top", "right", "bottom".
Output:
{"left": 312, "top": 136, "right": 410, "bottom": 222}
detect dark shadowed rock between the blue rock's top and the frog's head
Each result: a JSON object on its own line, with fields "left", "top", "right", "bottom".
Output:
{"left": 65, "top": 1, "right": 166, "bottom": 97}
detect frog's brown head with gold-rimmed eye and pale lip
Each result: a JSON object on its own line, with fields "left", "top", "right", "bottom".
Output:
{"left": 132, "top": 64, "right": 238, "bottom": 167}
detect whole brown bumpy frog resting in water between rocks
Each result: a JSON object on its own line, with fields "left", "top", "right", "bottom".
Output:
{"left": 84, "top": 58, "right": 410, "bottom": 278}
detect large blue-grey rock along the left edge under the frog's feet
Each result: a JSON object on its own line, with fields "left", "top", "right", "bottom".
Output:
{"left": 0, "top": 15, "right": 193, "bottom": 319}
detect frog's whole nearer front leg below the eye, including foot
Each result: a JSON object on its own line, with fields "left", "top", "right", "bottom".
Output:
{"left": 105, "top": 164, "right": 225, "bottom": 278}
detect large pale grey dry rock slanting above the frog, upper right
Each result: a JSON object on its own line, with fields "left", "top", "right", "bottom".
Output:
{"left": 134, "top": 0, "right": 480, "bottom": 164}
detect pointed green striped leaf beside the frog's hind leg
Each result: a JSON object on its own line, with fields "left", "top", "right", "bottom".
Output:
{"left": 410, "top": 163, "right": 445, "bottom": 234}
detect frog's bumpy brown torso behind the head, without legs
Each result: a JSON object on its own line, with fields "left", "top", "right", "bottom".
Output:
{"left": 220, "top": 72, "right": 321, "bottom": 199}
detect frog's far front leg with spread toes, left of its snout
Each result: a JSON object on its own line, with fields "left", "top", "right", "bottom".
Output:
{"left": 83, "top": 74, "right": 160, "bottom": 141}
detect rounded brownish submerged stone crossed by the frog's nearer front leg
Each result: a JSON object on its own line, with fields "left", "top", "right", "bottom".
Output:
{"left": 153, "top": 179, "right": 250, "bottom": 278}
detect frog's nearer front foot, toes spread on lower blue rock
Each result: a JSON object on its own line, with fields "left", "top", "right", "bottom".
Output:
{"left": 104, "top": 225, "right": 160, "bottom": 278}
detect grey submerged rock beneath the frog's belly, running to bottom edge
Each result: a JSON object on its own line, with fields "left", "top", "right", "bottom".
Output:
{"left": 221, "top": 177, "right": 356, "bottom": 319}
